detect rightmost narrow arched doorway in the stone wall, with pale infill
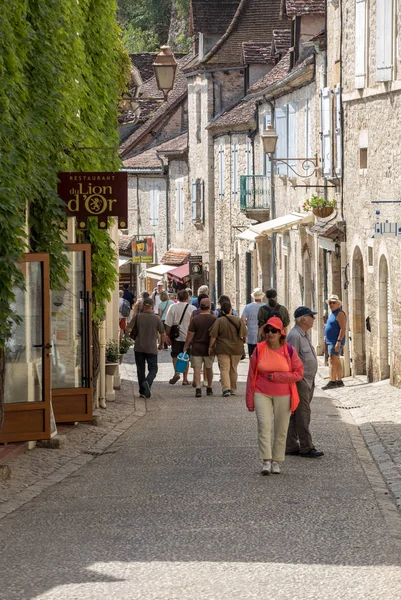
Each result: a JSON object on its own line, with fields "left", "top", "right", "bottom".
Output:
{"left": 378, "top": 254, "right": 390, "bottom": 379}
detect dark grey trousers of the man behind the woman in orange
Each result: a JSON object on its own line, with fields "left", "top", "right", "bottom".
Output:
{"left": 286, "top": 379, "right": 315, "bottom": 454}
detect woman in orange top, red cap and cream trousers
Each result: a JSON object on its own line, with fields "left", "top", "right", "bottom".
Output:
{"left": 246, "top": 317, "right": 304, "bottom": 475}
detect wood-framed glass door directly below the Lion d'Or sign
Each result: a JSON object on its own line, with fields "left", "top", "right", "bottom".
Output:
{"left": 51, "top": 244, "right": 92, "bottom": 423}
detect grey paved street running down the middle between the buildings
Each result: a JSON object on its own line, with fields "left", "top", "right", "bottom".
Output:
{"left": 0, "top": 353, "right": 401, "bottom": 600}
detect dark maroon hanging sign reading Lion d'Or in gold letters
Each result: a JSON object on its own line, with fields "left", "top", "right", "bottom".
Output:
{"left": 57, "top": 172, "right": 128, "bottom": 229}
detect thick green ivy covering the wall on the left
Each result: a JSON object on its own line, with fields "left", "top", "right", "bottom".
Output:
{"left": 0, "top": 0, "right": 129, "bottom": 348}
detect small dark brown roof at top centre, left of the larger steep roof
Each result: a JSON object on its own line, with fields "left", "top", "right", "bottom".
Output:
{"left": 189, "top": 0, "right": 239, "bottom": 35}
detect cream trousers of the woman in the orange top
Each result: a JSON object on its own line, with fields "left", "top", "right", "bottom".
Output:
{"left": 255, "top": 392, "right": 291, "bottom": 462}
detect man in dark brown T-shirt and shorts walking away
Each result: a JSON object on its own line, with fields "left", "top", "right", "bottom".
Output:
{"left": 184, "top": 298, "right": 216, "bottom": 398}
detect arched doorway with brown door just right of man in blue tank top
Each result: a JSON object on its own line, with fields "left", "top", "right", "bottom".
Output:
{"left": 352, "top": 246, "right": 366, "bottom": 375}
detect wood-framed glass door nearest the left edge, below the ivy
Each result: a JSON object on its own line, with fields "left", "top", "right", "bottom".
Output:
{"left": 0, "top": 253, "right": 51, "bottom": 442}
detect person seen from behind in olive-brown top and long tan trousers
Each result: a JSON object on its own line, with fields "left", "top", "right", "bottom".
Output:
{"left": 209, "top": 301, "right": 248, "bottom": 397}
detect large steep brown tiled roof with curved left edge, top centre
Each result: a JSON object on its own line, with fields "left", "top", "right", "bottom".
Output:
{"left": 184, "top": 0, "right": 288, "bottom": 72}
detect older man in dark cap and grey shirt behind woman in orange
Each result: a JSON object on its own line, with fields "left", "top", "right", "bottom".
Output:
{"left": 285, "top": 306, "right": 324, "bottom": 458}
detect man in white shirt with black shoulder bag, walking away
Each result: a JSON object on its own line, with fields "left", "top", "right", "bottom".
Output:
{"left": 165, "top": 290, "right": 196, "bottom": 385}
